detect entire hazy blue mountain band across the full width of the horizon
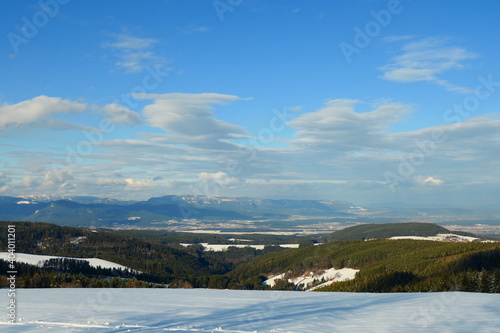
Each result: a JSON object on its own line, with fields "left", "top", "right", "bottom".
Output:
{"left": 0, "top": 195, "right": 500, "bottom": 228}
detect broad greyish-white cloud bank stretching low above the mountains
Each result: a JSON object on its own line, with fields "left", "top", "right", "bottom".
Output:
{"left": 0, "top": 94, "right": 500, "bottom": 203}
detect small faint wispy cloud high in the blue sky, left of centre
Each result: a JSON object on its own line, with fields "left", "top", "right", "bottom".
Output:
{"left": 103, "top": 34, "right": 167, "bottom": 73}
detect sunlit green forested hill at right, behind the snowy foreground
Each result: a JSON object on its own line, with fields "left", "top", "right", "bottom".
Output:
{"left": 227, "top": 239, "right": 500, "bottom": 292}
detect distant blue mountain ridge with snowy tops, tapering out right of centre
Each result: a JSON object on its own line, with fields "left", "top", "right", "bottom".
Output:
{"left": 0, "top": 195, "right": 363, "bottom": 227}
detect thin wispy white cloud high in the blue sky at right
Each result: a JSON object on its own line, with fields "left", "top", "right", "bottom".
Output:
{"left": 380, "top": 36, "right": 478, "bottom": 93}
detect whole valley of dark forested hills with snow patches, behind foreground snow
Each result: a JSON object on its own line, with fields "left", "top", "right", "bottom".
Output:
{"left": 0, "top": 222, "right": 500, "bottom": 293}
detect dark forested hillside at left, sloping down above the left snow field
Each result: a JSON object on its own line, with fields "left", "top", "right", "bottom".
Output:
{"left": 0, "top": 222, "right": 228, "bottom": 283}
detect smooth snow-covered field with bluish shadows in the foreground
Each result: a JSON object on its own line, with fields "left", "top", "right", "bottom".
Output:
{"left": 0, "top": 289, "right": 500, "bottom": 333}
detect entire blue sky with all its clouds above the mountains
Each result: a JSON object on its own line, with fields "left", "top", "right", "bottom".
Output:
{"left": 0, "top": 0, "right": 500, "bottom": 207}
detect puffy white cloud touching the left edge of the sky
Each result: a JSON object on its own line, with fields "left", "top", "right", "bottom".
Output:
{"left": 0, "top": 95, "right": 87, "bottom": 129}
